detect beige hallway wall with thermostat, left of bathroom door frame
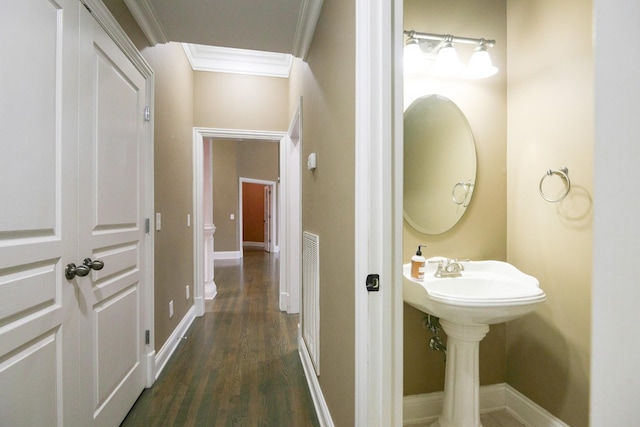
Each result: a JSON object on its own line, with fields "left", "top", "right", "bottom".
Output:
{"left": 289, "top": 0, "right": 356, "bottom": 426}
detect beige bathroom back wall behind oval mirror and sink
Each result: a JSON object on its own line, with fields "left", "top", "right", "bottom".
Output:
{"left": 403, "top": 0, "right": 507, "bottom": 395}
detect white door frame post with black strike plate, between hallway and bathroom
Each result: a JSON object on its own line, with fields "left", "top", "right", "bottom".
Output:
{"left": 355, "top": 0, "right": 403, "bottom": 427}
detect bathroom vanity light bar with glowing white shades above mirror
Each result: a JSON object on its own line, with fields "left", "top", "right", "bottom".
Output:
{"left": 404, "top": 30, "right": 498, "bottom": 79}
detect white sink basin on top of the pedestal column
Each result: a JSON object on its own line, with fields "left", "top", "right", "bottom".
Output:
{"left": 402, "top": 257, "right": 547, "bottom": 325}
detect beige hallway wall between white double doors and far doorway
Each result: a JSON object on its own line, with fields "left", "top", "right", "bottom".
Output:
{"left": 142, "top": 43, "right": 193, "bottom": 350}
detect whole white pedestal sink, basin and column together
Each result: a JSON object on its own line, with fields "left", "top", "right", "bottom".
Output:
{"left": 403, "top": 257, "right": 547, "bottom": 427}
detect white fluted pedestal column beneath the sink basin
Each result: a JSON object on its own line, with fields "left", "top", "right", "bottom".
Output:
{"left": 432, "top": 319, "right": 489, "bottom": 427}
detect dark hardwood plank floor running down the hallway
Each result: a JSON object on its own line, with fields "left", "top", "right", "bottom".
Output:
{"left": 121, "top": 250, "right": 319, "bottom": 427}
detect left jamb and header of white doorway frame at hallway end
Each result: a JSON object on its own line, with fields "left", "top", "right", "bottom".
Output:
{"left": 192, "top": 127, "right": 286, "bottom": 316}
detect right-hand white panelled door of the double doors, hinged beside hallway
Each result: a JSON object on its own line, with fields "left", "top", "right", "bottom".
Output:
{"left": 78, "top": 8, "right": 146, "bottom": 426}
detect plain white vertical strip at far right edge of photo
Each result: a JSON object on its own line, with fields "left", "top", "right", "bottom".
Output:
{"left": 591, "top": 0, "right": 640, "bottom": 427}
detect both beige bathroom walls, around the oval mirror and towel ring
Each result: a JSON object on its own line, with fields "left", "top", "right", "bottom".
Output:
{"left": 404, "top": 0, "right": 594, "bottom": 426}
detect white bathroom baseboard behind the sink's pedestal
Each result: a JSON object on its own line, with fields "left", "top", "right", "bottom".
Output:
{"left": 403, "top": 383, "right": 569, "bottom": 427}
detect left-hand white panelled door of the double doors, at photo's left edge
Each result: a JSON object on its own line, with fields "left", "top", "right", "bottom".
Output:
{"left": 0, "top": 0, "right": 81, "bottom": 426}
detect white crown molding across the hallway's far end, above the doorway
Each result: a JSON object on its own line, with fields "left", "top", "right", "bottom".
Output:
{"left": 182, "top": 43, "right": 293, "bottom": 78}
